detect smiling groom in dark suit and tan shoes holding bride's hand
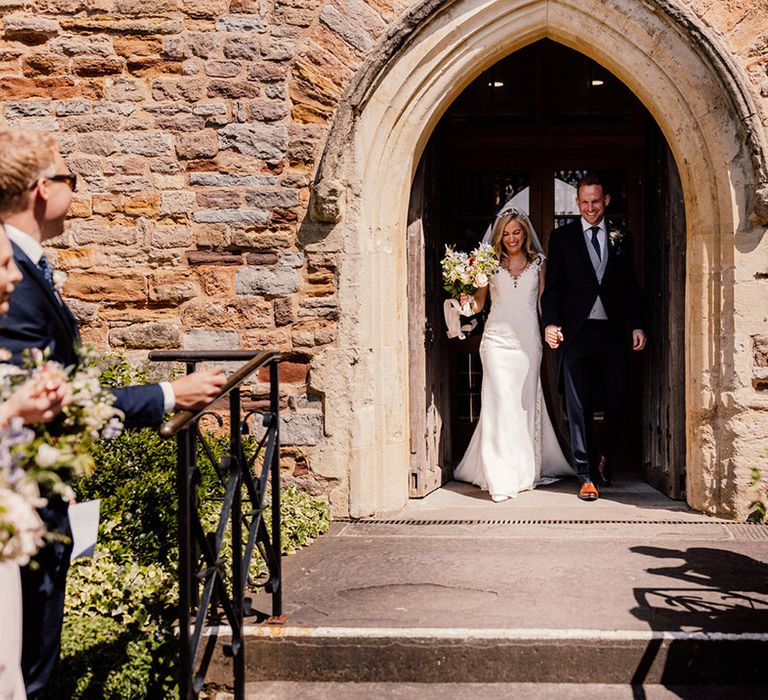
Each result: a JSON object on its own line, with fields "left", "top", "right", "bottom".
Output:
{"left": 541, "top": 176, "right": 645, "bottom": 501}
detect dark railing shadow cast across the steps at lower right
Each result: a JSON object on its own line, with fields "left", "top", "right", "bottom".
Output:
{"left": 630, "top": 546, "right": 768, "bottom": 700}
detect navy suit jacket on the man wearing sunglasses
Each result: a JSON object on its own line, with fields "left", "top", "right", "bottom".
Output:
{"left": 0, "top": 243, "right": 164, "bottom": 427}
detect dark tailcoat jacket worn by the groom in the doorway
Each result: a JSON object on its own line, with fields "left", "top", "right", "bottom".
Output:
{"left": 541, "top": 218, "right": 644, "bottom": 374}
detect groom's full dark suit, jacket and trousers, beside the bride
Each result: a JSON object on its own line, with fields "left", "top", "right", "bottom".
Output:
{"left": 541, "top": 218, "right": 644, "bottom": 481}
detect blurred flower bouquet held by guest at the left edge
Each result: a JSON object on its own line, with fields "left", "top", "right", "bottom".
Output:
{"left": 0, "top": 350, "right": 123, "bottom": 565}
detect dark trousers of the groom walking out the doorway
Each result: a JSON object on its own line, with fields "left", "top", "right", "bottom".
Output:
{"left": 562, "top": 320, "right": 624, "bottom": 482}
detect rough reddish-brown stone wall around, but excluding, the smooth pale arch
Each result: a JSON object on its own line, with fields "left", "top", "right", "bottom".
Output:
{"left": 0, "top": 0, "right": 768, "bottom": 512}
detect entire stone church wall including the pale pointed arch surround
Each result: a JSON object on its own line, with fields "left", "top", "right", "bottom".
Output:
{"left": 0, "top": 0, "right": 768, "bottom": 517}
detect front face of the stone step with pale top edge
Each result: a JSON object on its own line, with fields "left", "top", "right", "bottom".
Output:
{"left": 208, "top": 626, "right": 768, "bottom": 687}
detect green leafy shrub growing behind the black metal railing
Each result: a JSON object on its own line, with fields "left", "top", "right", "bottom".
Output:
{"left": 46, "top": 356, "right": 330, "bottom": 700}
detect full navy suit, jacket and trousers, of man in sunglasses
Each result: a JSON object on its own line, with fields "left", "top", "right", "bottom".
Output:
{"left": 0, "top": 243, "right": 164, "bottom": 697}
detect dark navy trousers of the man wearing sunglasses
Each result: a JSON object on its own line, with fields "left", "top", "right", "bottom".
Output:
{"left": 21, "top": 496, "right": 72, "bottom": 698}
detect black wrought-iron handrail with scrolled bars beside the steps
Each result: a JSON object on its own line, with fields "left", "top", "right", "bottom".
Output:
{"left": 149, "top": 351, "right": 282, "bottom": 700}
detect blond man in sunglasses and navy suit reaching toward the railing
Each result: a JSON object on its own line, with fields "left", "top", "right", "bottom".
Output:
{"left": 0, "top": 129, "right": 225, "bottom": 698}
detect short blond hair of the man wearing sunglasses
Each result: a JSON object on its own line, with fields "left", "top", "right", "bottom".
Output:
{"left": 0, "top": 129, "right": 56, "bottom": 217}
